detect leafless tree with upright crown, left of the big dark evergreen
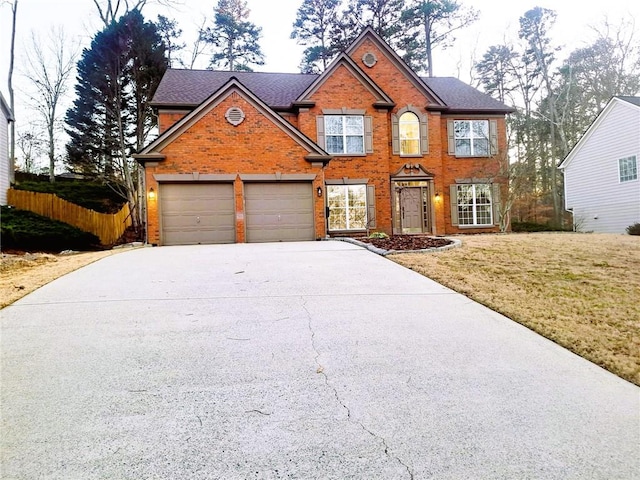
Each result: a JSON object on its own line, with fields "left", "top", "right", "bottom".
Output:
{"left": 24, "top": 28, "right": 77, "bottom": 183}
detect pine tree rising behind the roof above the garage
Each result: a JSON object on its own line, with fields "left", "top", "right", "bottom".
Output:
{"left": 201, "top": 0, "right": 264, "bottom": 71}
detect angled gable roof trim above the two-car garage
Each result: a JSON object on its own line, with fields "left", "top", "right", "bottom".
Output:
{"left": 139, "top": 77, "right": 331, "bottom": 163}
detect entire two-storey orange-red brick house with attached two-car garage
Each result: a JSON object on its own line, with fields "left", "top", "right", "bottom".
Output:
{"left": 135, "top": 28, "right": 513, "bottom": 245}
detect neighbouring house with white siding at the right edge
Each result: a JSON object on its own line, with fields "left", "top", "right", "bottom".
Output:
{"left": 558, "top": 96, "right": 640, "bottom": 233}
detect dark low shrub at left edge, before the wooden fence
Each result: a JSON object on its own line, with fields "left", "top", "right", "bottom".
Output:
{"left": 0, "top": 207, "right": 100, "bottom": 252}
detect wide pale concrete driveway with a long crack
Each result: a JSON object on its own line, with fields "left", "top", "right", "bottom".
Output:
{"left": 1, "top": 242, "right": 640, "bottom": 480}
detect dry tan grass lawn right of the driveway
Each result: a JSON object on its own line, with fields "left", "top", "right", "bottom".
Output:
{"left": 389, "top": 233, "right": 640, "bottom": 385}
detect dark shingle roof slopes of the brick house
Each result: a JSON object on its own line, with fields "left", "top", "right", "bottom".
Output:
{"left": 152, "top": 69, "right": 514, "bottom": 113}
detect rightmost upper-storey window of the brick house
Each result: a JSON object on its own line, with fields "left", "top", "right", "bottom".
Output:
{"left": 447, "top": 120, "right": 498, "bottom": 157}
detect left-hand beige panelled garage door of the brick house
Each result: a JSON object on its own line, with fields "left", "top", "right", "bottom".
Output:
{"left": 159, "top": 183, "right": 236, "bottom": 245}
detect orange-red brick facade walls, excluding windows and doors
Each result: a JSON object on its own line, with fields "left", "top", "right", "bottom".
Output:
{"left": 136, "top": 30, "right": 508, "bottom": 244}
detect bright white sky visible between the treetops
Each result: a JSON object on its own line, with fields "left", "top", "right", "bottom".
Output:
{"left": 0, "top": 0, "right": 640, "bottom": 171}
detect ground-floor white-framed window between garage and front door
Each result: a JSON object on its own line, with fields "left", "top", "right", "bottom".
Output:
{"left": 327, "top": 185, "right": 367, "bottom": 230}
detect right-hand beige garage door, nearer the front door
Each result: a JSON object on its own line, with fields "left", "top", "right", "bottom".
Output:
{"left": 244, "top": 183, "right": 315, "bottom": 242}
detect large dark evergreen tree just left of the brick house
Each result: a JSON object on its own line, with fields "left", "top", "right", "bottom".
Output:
{"left": 66, "top": 10, "right": 167, "bottom": 225}
